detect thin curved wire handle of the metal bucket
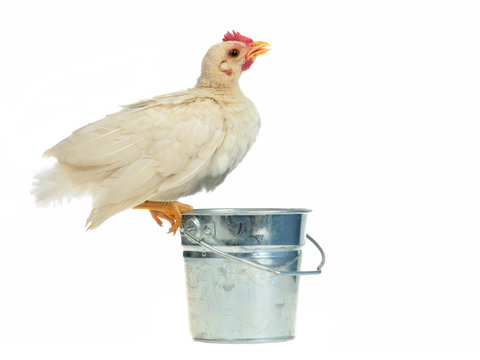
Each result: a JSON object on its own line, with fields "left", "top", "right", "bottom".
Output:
{"left": 180, "top": 227, "right": 325, "bottom": 276}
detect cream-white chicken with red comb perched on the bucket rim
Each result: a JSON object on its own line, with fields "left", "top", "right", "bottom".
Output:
{"left": 32, "top": 31, "right": 270, "bottom": 233}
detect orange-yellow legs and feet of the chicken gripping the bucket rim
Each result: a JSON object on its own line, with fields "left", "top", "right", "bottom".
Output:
{"left": 134, "top": 200, "right": 193, "bottom": 235}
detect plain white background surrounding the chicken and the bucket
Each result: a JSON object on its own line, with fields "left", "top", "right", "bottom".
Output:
{"left": 0, "top": 0, "right": 480, "bottom": 359}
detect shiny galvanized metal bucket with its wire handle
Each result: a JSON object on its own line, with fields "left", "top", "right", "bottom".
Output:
{"left": 180, "top": 209, "right": 325, "bottom": 343}
